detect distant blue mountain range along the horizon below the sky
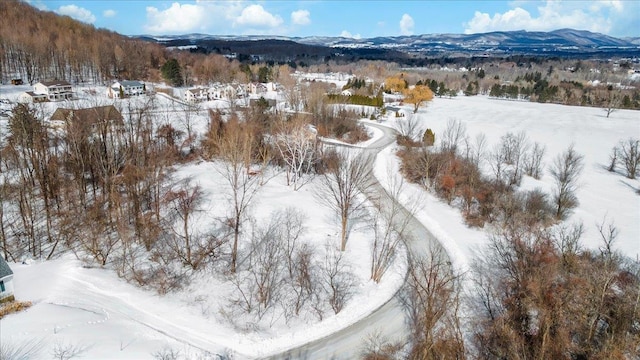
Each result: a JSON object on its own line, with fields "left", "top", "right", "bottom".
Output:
{"left": 140, "top": 29, "right": 640, "bottom": 58}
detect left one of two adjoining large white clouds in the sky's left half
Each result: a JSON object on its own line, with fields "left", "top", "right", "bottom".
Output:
{"left": 145, "top": 2, "right": 206, "bottom": 34}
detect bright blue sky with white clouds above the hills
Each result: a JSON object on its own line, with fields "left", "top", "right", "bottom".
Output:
{"left": 26, "top": 0, "right": 640, "bottom": 38}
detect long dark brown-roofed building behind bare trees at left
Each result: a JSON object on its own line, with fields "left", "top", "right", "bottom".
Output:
{"left": 49, "top": 105, "right": 124, "bottom": 133}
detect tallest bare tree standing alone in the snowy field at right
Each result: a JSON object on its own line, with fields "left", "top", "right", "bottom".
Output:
{"left": 549, "top": 145, "right": 584, "bottom": 220}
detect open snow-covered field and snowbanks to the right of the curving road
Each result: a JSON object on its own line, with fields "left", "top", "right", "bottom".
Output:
{"left": 376, "top": 96, "right": 640, "bottom": 269}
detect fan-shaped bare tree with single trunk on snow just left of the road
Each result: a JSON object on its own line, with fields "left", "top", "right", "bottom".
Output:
{"left": 315, "top": 151, "right": 373, "bottom": 251}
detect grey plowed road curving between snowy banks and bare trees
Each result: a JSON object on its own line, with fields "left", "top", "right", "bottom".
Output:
{"left": 268, "top": 122, "right": 448, "bottom": 360}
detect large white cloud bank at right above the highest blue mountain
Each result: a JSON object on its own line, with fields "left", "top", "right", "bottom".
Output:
{"left": 463, "top": 0, "right": 633, "bottom": 34}
